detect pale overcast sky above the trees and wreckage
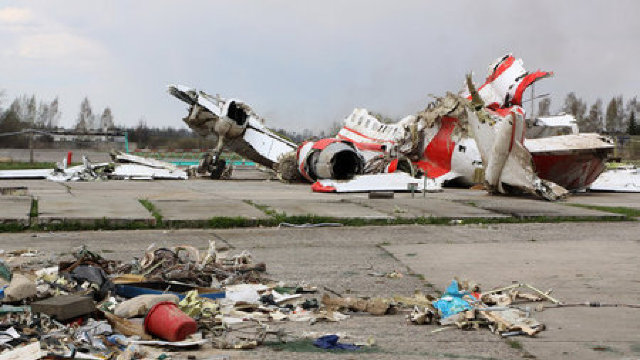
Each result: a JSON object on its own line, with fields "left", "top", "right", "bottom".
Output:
{"left": 0, "top": 0, "right": 640, "bottom": 130}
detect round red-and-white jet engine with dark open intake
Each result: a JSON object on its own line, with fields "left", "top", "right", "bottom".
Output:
{"left": 297, "top": 139, "right": 365, "bottom": 182}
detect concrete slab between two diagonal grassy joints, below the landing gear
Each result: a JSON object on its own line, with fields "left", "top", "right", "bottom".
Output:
{"left": 151, "top": 199, "right": 270, "bottom": 222}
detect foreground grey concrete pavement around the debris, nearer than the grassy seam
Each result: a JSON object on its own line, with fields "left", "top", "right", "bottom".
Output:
{"left": 0, "top": 222, "right": 640, "bottom": 359}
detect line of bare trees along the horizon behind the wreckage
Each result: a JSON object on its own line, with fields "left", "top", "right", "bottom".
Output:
{"left": 0, "top": 90, "right": 640, "bottom": 149}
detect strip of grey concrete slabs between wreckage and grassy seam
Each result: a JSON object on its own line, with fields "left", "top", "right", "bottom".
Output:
{"left": 0, "top": 179, "right": 640, "bottom": 224}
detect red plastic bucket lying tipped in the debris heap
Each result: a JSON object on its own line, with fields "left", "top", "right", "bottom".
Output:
{"left": 144, "top": 301, "right": 198, "bottom": 341}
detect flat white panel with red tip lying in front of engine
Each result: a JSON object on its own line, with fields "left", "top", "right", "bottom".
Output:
{"left": 311, "top": 172, "right": 442, "bottom": 193}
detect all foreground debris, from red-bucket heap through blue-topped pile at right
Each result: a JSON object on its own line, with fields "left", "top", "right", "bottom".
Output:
{"left": 0, "top": 245, "right": 640, "bottom": 359}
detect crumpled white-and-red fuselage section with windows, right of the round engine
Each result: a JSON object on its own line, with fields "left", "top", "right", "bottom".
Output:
{"left": 337, "top": 107, "right": 482, "bottom": 185}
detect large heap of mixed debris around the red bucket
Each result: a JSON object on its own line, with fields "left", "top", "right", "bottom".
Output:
{"left": 0, "top": 241, "right": 394, "bottom": 359}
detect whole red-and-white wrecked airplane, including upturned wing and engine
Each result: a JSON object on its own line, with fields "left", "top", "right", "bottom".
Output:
{"left": 169, "top": 55, "right": 614, "bottom": 200}
